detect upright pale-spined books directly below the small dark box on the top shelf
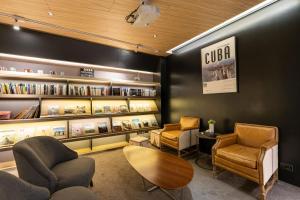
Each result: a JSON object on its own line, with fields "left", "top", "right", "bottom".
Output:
{"left": 69, "top": 85, "right": 107, "bottom": 96}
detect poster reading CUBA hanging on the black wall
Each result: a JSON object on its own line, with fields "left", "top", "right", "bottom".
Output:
{"left": 201, "top": 37, "right": 237, "bottom": 94}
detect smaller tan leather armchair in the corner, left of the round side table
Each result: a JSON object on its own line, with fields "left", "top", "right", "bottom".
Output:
{"left": 160, "top": 117, "right": 200, "bottom": 156}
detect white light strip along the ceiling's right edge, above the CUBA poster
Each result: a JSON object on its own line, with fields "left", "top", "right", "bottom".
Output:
{"left": 166, "top": 0, "right": 279, "bottom": 54}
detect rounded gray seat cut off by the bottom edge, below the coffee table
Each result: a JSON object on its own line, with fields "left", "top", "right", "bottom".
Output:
{"left": 50, "top": 186, "right": 97, "bottom": 200}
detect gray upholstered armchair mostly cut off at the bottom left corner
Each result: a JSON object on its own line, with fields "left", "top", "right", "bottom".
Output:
{"left": 0, "top": 171, "right": 97, "bottom": 200}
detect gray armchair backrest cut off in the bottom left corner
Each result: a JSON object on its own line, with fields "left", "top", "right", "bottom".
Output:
{"left": 0, "top": 171, "right": 50, "bottom": 200}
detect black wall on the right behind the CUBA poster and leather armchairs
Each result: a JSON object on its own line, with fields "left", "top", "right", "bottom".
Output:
{"left": 167, "top": 0, "right": 300, "bottom": 185}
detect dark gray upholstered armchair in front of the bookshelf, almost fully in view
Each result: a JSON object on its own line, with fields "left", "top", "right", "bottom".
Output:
{"left": 13, "top": 136, "right": 95, "bottom": 193}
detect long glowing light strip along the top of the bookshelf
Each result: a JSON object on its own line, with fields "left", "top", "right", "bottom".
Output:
{"left": 0, "top": 53, "right": 159, "bottom": 75}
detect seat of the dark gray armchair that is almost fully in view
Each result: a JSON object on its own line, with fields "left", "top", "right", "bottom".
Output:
{"left": 52, "top": 157, "right": 95, "bottom": 190}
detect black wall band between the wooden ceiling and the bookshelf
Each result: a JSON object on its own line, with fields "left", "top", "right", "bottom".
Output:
{"left": 0, "top": 24, "right": 160, "bottom": 72}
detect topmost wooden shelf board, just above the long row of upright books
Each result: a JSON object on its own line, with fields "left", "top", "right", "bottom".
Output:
{"left": 0, "top": 71, "right": 160, "bottom": 87}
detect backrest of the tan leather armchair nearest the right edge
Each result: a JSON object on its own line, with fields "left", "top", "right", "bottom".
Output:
{"left": 234, "top": 123, "right": 278, "bottom": 148}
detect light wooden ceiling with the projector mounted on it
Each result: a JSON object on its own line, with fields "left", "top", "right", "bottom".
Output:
{"left": 0, "top": 0, "right": 262, "bottom": 56}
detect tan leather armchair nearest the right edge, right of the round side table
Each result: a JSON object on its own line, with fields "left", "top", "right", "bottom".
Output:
{"left": 212, "top": 123, "right": 278, "bottom": 200}
